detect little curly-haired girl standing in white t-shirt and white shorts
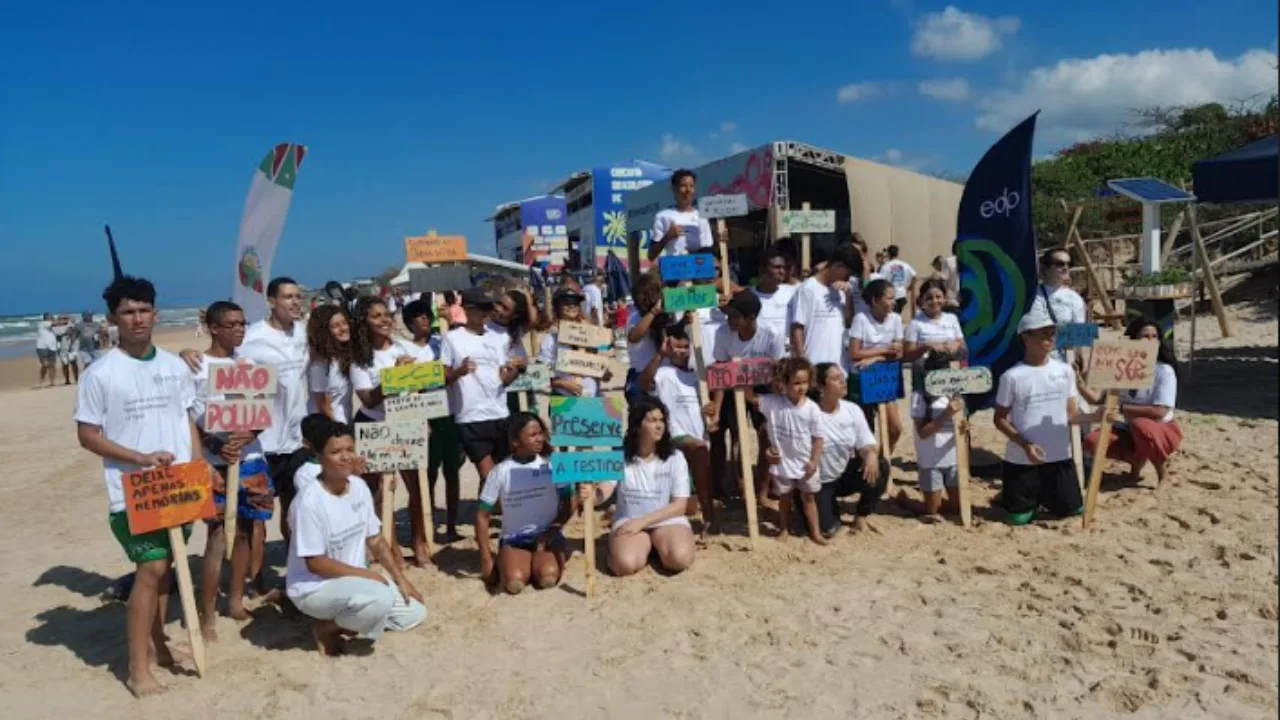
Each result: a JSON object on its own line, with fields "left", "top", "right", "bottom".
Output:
{"left": 759, "top": 357, "right": 827, "bottom": 544}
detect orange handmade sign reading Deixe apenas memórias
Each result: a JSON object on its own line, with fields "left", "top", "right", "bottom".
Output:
{"left": 123, "top": 460, "right": 218, "bottom": 536}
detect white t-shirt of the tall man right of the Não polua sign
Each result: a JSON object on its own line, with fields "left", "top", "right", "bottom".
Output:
{"left": 236, "top": 320, "right": 311, "bottom": 454}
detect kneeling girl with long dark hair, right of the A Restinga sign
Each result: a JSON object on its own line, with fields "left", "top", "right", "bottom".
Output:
{"left": 579, "top": 396, "right": 694, "bottom": 577}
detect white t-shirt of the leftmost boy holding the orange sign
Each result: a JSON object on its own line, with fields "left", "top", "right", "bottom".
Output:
{"left": 76, "top": 348, "right": 196, "bottom": 512}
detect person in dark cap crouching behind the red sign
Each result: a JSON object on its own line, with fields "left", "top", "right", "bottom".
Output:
{"left": 710, "top": 290, "right": 786, "bottom": 498}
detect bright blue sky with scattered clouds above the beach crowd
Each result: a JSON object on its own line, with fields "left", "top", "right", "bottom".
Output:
{"left": 0, "top": 0, "right": 1277, "bottom": 314}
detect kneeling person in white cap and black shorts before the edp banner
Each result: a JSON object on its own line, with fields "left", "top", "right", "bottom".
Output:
{"left": 995, "top": 306, "right": 1101, "bottom": 525}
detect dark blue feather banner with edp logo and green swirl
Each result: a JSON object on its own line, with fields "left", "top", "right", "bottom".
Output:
{"left": 954, "top": 114, "right": 1036, "bottom": 411}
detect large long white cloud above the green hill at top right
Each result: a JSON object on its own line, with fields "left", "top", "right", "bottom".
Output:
{"left": 977, "top": 49, "right": 1276, "bottom": 142}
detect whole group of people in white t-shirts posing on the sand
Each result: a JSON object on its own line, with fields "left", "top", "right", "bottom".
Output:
{"left": 76, "top": 170, "right": 1180, "bottom": 694}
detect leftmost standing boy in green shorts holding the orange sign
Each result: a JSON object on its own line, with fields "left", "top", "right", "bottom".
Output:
{"left": 76, "top": 275, "right": 200, "bottom": 697}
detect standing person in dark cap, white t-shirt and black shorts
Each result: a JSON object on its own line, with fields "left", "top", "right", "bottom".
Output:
{"left": 440, "top": 287, "right": 525, "bottom": 487}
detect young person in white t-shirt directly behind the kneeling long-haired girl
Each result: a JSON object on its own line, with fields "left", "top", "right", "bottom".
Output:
{"left": 637, "top": 323, "right": 719, "bottom": 537}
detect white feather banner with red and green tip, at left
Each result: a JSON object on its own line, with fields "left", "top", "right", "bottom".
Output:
{"left": 232, "top": 142, "right": 307, "bottom": 323}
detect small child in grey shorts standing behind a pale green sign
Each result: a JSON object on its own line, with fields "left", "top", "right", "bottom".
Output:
{"left": 897, "top": 350, "right": 964, "bottom": 523}
